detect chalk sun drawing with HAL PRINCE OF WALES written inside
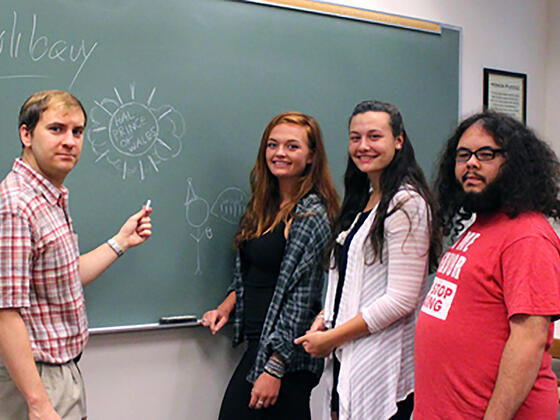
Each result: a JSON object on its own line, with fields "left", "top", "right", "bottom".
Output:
{"left": 87, "top": 83, "right": 185, "bottom": 181}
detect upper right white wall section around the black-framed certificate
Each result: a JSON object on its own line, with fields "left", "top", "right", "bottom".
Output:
{"left": 327, "top": 0, "right": 547, "bottom": 128}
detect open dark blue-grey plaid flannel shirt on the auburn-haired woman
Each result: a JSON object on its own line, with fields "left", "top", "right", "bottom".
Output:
{"left": 228, "top": 194, "right": 331, "bottom": 383}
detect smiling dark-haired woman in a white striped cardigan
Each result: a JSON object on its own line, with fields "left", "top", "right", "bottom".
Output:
{"left": 295, "top": 101, "right": 441, "bottom": 420}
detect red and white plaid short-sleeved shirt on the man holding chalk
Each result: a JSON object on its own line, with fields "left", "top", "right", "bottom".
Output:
{"left": 0, "top": 159, "right": 88, "bottom": 363}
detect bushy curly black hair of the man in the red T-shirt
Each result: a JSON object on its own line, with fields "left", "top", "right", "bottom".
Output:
{"left": 434, "top": 111, "right": 560, "bottom": 236}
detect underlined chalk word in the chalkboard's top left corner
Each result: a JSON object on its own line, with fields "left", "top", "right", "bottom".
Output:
{"left": 0, "top": 10, "right": 98, "bottom": 89}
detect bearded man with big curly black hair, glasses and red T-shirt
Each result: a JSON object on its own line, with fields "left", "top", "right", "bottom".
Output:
{"left": 414, "top": 111, "right": 560, "bottom": 420}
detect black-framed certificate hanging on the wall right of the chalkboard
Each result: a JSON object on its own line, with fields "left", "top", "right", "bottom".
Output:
{"left": 483, "top": 68, "right": 527, "bottom": 124}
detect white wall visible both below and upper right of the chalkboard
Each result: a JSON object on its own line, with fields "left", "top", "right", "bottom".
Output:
{"left": 81, "top": 0, "right": 560, "bottom": 420}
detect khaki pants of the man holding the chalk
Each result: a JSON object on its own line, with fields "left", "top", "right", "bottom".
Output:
{"left": 0, "top": 361, "right": 87, "bottom": 420}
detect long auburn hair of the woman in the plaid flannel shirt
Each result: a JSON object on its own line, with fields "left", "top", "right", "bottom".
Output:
{"left": 234, "top": 111, "right": 339, "bottom": 248}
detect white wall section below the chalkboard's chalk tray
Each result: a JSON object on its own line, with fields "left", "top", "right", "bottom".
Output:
{"left": 80, "top": 327, "right": 241, "bottom": 420}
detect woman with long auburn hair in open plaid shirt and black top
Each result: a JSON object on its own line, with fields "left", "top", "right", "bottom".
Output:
{"left": 202, "top": 112, "right": 338, "bottom": 420}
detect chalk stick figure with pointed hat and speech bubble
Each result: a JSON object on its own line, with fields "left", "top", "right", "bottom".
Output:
{"left": 185, "top": 178, "right": 247, "bottom": 275}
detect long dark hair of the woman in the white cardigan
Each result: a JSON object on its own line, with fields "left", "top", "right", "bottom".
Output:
{"left": 330, "top": 101, "right": 441, "bottom": 272}
